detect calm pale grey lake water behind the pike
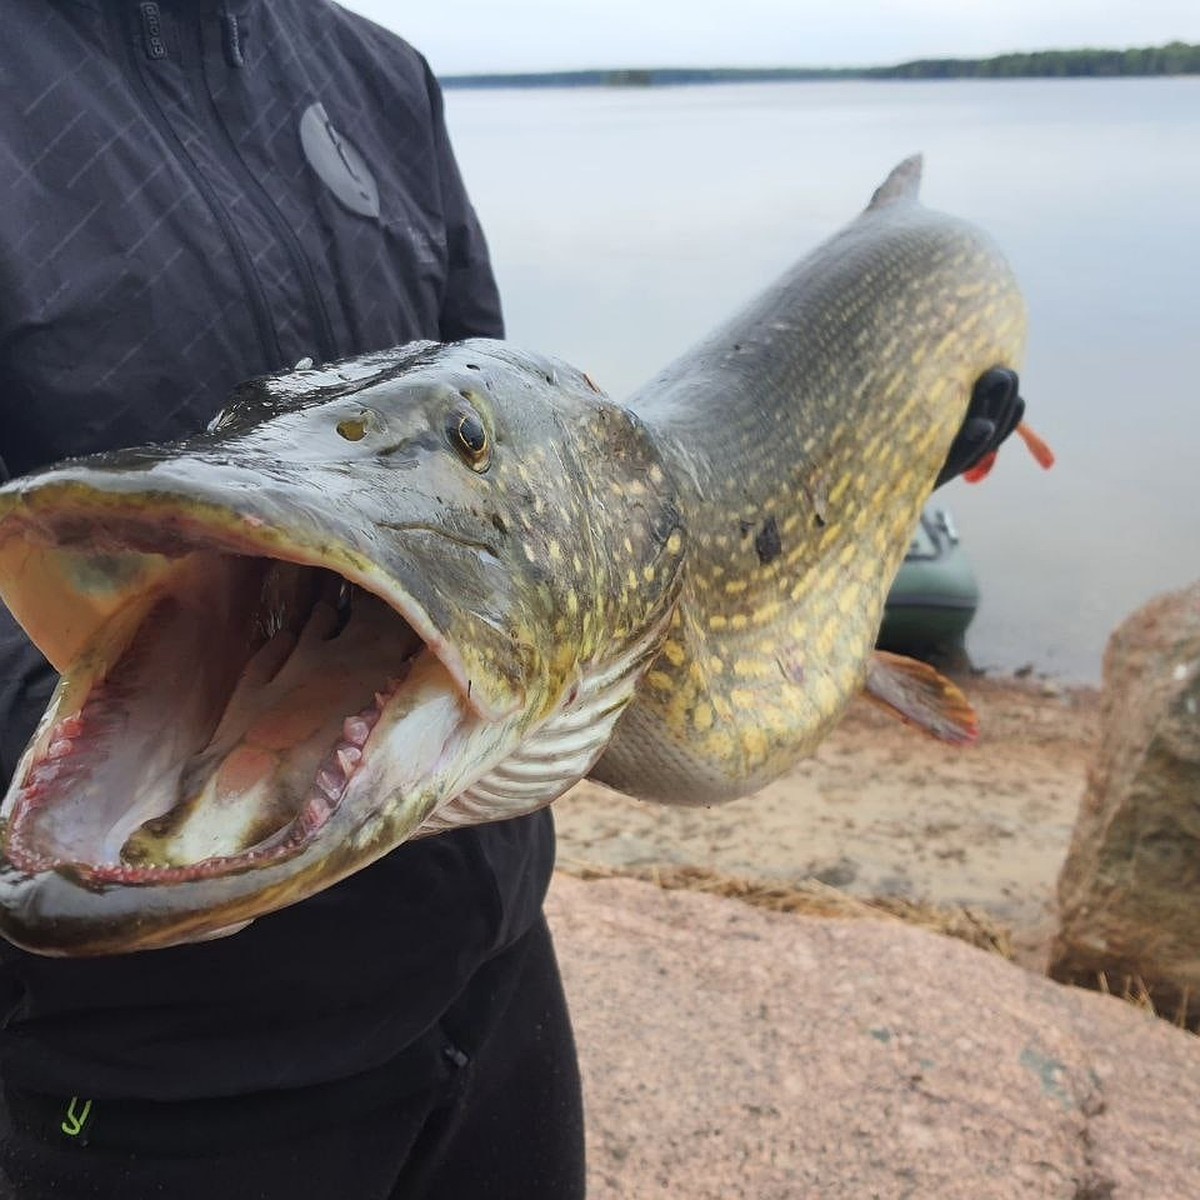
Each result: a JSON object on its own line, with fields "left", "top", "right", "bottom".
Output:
{"left": 446, "top": 78, "right": 1200, "bottom": 682}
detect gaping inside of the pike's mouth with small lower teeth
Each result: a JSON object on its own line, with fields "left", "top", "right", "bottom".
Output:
{"left": 5, "top": 548, "right": 441, "bottom": 887}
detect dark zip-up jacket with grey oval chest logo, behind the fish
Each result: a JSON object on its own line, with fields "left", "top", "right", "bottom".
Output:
{"left": 0, "top": 0, "right": 553, "bottom": 1099}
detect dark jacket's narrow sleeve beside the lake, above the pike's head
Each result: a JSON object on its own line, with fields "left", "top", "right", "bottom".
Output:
{"left": 425, "top": 64, "right": 504, "bottom": 342}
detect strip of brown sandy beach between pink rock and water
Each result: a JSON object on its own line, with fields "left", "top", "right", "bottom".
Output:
{"left": 556, "top": 676, "right": 1098, "bottom": 968}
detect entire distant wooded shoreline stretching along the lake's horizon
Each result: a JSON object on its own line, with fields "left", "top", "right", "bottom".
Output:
{"left": 442, "top": 42, "right": 1200, "bottom": 88}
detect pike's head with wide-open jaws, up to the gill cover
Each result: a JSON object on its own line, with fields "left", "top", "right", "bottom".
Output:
{"left": 0, "top": 340, "right": 683, "bottom": 954}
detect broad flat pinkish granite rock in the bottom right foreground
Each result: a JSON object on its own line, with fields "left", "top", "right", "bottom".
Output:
{"left": 547, "top": 875, "right": 1200, "bottom": 1200}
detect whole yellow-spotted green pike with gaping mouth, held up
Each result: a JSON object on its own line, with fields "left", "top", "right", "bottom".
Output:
{"left": 0, "top": 160, "right": 1025, "bottom": 954}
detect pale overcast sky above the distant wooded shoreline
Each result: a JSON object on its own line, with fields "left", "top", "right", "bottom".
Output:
{"left": 342, "top": 0, "right": 1200, "bottom": 74}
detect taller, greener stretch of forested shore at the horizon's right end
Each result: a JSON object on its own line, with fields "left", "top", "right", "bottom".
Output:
{"left": 863, "top": 42, "right": 1200, "bottom": 79}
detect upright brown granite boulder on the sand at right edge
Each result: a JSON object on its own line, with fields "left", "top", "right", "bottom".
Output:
{"left": 1050, "top": 582, "right": 1200, "bottom": 1022}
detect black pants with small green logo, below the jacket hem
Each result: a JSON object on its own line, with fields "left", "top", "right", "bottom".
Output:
{"left": 0, "top": 922, "right": 584, "bottom": 1200}
